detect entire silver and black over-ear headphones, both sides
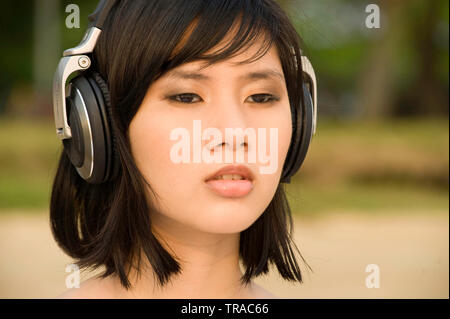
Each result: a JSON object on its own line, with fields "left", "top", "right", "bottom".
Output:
{"left": 53, "top": 0, "right": 317, "bottom": 184}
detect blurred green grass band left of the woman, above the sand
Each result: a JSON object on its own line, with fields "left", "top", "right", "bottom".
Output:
{"left": 0, "top": 118, "right": 61, "bottom": 209}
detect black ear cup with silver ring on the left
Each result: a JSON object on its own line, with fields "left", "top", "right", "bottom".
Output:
{"left": 63, "top": 73, "right": 114, "bottom": 184}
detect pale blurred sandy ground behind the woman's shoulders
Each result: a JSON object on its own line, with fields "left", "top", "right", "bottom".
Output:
{"left": 0, "top": 212, "right": 449, "bottom": 298}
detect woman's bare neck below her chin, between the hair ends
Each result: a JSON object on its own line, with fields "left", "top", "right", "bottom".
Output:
{"left": 107, "top": 211, "right": 251, "bottom": 299}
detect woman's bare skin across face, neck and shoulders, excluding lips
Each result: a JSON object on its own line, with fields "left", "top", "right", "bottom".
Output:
{"left": 58, "top": 27, "right": 292, "bottom": 298}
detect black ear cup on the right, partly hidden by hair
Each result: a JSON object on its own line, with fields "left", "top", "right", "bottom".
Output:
{"left": 280, "top": 84, "right": 314, "bottom": 183}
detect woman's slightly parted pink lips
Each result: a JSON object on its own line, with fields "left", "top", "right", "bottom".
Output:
{"left": 205, "top": 165, "right": 254, "bottom": 198}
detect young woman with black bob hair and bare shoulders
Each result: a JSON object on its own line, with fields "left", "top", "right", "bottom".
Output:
{"left": 50, "top": 0, "right": 314, "bottom": 298}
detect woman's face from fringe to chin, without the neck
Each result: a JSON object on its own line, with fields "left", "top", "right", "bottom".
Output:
{"left": 129, "top": 40, "right": 292, "bottom": 233}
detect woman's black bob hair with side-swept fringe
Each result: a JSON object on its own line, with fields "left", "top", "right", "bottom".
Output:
{"left": 50, "top": 0, "right": 309, "bottom": 289}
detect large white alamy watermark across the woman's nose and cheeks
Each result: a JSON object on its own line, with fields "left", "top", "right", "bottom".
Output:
{"left": 170, "top": 120, "right": 278, "bottom": 174}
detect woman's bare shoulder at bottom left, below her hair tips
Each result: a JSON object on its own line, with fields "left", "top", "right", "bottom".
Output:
{"left": 55, "top": 276, "right": 114, "bottom": 299}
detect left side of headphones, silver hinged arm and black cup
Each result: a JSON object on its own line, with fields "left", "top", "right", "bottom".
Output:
{"left": 53, "top": 0, "right": 118, "bottom": 184}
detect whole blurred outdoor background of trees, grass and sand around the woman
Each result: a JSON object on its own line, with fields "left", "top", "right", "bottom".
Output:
{"left": 0, "top": 0, "right": 449, "bottom": 298}
